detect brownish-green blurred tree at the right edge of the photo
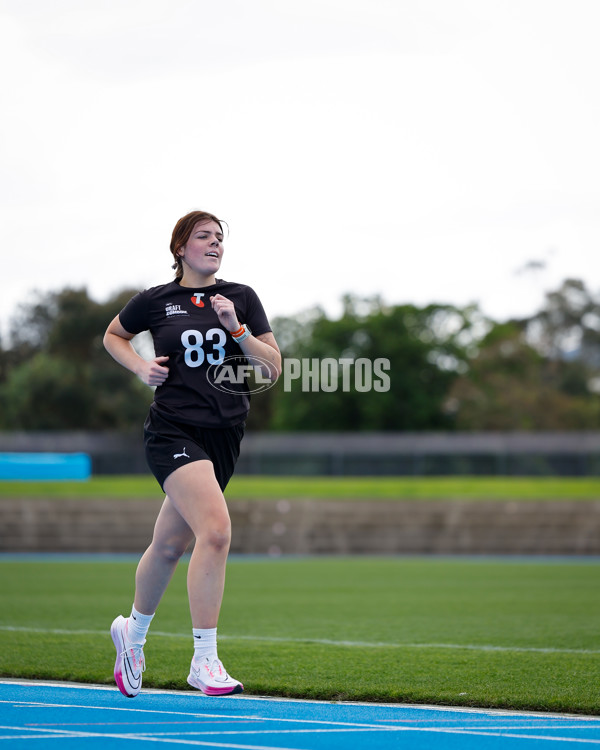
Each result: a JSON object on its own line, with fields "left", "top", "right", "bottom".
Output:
{"left": 446, "top": 280, "right": 600, "bottom": 430}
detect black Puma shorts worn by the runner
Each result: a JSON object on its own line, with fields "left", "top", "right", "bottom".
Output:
{"left": 144, "top": 409, "right": 245, "bottom": 491}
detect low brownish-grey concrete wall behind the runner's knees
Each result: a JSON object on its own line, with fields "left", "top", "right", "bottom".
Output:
{"left": 0, "top": 499, "right": 600, "bottom": 555}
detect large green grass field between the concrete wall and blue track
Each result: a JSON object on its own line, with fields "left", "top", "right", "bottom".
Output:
{"left": 0, "top": 557, "right": 600, "bottom": 714}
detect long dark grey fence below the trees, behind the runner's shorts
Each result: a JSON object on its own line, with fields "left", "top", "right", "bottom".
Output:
{"left": 0, "top": 432, "right": 600, "bottom": 476}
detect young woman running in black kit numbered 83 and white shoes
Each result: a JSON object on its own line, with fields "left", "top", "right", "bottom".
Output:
{"left": 104, "top": 211, "right": 281, "bottom": 698}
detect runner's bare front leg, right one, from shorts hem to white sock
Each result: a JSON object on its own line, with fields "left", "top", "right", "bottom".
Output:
{"left": 165, "top": 461, "right": 231, "bottom": 628}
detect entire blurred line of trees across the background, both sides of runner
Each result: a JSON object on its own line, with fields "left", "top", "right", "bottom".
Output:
{"left": 0, "top": 279, "right": 600, "bottom": 431}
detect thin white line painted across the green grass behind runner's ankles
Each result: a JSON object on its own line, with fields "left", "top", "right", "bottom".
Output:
{"left": 0, "top": 625, "right": 600, "bottom": 655}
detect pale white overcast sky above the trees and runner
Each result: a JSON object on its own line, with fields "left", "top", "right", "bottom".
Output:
{"left": 0, "top": 0, "right": 600, "bottom": 338}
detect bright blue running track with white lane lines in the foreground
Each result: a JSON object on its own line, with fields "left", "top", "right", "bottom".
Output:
{"left": 0, "top": 680, "right": 600, "bottom": 750}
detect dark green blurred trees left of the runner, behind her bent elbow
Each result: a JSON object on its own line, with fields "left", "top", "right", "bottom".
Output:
{"left": 0, "top": 289, "right": 152, "bottom": 430}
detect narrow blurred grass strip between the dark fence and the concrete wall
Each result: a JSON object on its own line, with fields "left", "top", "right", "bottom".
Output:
{"left": 0, "top": 475, "right": 600, "bottom": 500}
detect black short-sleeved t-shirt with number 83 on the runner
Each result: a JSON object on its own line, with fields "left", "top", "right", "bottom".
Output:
{"left": 119, "top": 279, "right": 271, "bottom": 427}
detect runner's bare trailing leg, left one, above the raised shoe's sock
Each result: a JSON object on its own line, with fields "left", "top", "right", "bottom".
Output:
{"left": 133, "top": 495, "right": 194, "bottom": 615}
